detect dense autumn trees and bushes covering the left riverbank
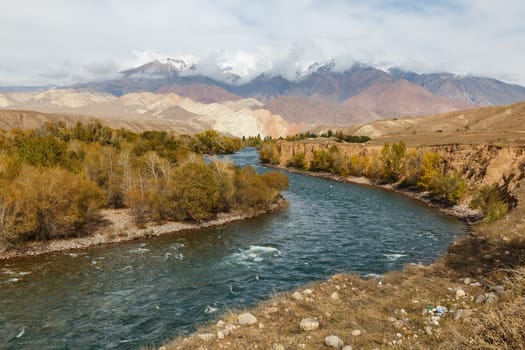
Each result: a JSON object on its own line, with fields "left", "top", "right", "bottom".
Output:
{"left": 0, "top": 121, "right": 288, "bottom": 249}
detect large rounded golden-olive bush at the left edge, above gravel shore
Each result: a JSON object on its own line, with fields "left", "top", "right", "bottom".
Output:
{"left": 0, "top": 166, "right": 103, "bottom": 241}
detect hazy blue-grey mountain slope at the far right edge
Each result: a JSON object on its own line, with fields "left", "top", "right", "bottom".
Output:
{"left": 389, "top": 68, "right": 525, "bottom": 106}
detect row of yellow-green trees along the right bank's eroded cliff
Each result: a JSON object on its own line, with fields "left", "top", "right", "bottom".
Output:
{"left": 259, "top": 141, "right": 509, "bottom": 221}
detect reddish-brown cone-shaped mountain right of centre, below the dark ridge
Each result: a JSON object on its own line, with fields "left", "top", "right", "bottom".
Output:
{"left": 343, "top": 79, "right": 472, "bottom": 117}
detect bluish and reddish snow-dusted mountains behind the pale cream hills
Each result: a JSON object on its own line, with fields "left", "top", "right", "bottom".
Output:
{"left": 73, "top": 59, "right": 525, "bottom": 126}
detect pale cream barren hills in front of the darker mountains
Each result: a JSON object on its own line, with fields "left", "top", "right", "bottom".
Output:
{"left": 0, "top": 89, "right": 292, "bottom": 137}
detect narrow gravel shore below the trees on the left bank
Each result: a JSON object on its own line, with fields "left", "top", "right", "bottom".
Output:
{"left": 0, "top": 197, "right": 288, "bottom": 260}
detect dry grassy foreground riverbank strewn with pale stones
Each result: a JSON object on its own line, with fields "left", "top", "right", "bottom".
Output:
{"left": 160, "top": 174, "right": 525, "bottom": 350}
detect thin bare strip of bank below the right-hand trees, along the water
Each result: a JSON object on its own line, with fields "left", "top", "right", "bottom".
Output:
{"left": 266, "top": 164, "right": 482, "bottom": 225}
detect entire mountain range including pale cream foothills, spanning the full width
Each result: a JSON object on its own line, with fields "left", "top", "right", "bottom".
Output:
{"left": 0, "top": 58, "right": 525, "bottom": 136}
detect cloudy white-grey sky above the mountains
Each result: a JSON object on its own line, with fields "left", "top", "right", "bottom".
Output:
{"left": 0, "top": 0, "right": 525, "bottom": 86}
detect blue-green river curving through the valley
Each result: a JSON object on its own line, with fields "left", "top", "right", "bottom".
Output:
{"left": 0, "top": 149, "right": 464, "bottom": 349}
